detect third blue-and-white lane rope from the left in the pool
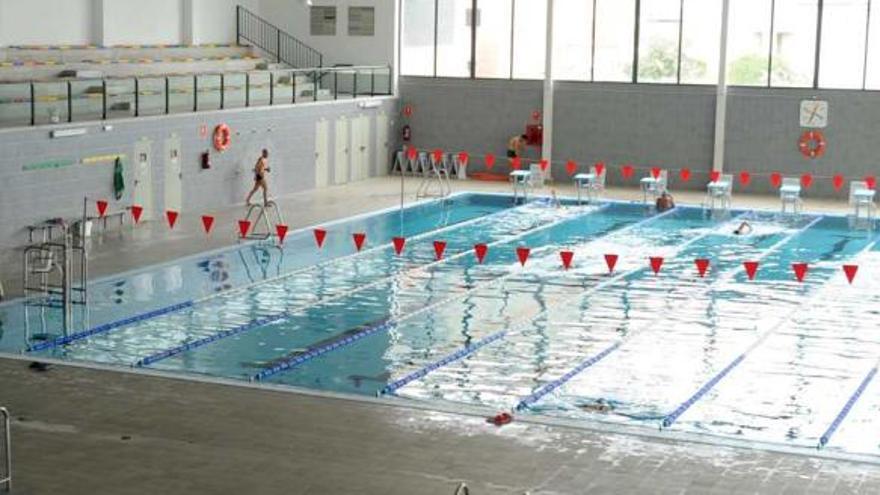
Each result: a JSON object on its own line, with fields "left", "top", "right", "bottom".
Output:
{"left": 251, "top": 209, "right": 675, "bottom": 381}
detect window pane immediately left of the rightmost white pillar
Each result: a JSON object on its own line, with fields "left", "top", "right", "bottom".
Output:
{"left": 681, "top": 0, "right": 722, "bottom": 84}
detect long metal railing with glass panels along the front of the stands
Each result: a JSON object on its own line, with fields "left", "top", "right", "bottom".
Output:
{"left": 0, "top": 66, "right": 392, "bottom": 127}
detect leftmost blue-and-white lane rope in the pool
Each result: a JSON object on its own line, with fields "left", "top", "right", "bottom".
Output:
{"left": 26, "top": 203, "right": 564, "bottom": 357}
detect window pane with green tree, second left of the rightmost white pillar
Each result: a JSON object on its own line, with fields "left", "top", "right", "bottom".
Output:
{"left": 638, "top": 0, "right": 681, "bottom": 83}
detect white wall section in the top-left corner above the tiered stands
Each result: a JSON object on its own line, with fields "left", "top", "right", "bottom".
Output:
{"left": 0, "top": 0, "right": 94, "bottom": 46}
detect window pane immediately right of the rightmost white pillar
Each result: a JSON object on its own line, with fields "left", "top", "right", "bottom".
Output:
{"left": 727, "top": 0, "right": 771, "bottom": 86}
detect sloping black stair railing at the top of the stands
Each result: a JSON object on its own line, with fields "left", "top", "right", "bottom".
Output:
{"left": 235, "top": 5, "right": 324, "bottom": 69}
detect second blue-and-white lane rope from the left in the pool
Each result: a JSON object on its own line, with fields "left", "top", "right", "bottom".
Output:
{"left": 134, "top": 205, "right": 608, "bottom": 369}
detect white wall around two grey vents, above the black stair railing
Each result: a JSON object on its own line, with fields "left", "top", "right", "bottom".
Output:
{"left": 260, "top": 0, "right": 394, "bottom": 65}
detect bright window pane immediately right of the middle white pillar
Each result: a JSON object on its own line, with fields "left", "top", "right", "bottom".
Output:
{"left": 553, "top": 0, "right": 595, "bottom": 81}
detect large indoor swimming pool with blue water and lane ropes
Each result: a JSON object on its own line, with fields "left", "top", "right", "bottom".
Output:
{"left": 0, "top": 194, "right": 880, "bottom": 462}
